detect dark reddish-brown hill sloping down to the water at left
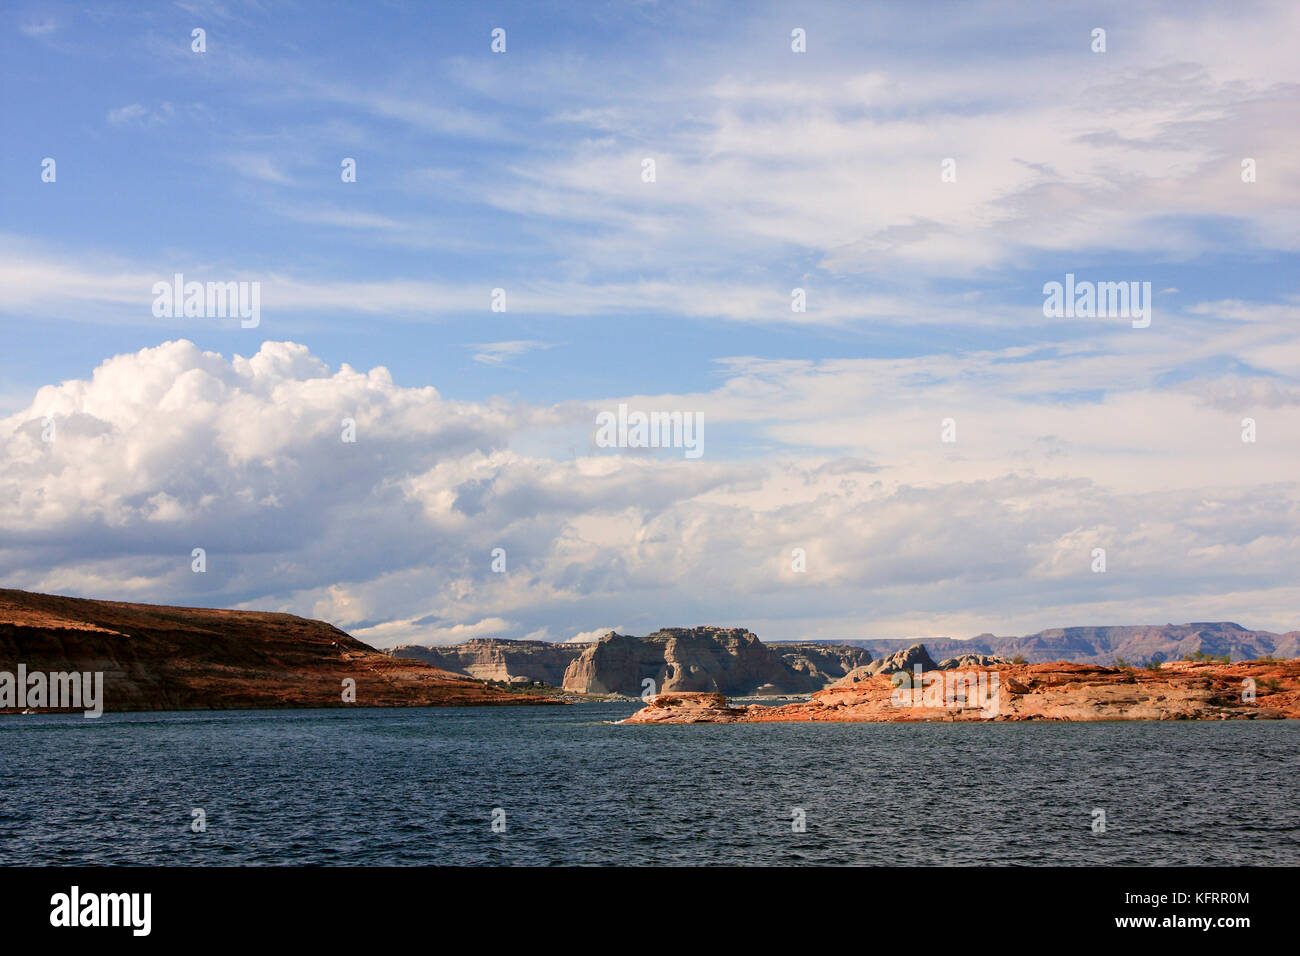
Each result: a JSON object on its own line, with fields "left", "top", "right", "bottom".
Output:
{"left": 0, "top": 589, "right": 555, "bottom": 714}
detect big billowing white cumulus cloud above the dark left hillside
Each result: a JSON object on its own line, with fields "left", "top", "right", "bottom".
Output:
{"left": 0, "top": 341, "right": 546, "bottom": 608}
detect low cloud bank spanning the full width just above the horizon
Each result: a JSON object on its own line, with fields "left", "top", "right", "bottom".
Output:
{"left": 0, "top": 341, "right": 1300, "bottom": 646}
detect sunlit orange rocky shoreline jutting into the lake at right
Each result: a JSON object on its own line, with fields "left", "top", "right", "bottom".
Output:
{"left": 623, "top": 658, "right": 1300, "bottom": 723}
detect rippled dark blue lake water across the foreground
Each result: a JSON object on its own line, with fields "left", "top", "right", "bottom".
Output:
{"left": 0, "top": 704, "right": 1300, "bottom": 865}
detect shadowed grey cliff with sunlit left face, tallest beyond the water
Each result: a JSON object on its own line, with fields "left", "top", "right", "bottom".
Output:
{"left": 564, "top": 627, "right": 822, "bottom": 697}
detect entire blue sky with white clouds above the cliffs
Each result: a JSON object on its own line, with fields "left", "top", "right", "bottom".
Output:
{"left": 0, "top": 0, "right": 1300, "bottom": 646}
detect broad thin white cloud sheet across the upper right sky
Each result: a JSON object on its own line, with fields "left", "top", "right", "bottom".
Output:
{"left": 452, "top": 5, "right": 1300, "bottom": 281}
